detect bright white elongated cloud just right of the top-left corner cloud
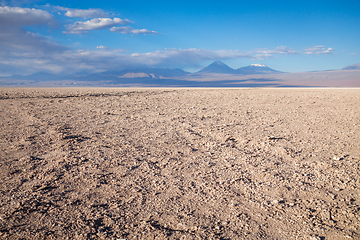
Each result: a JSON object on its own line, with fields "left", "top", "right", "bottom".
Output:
{"left": 64, "top": 18, "right": 131, "bottom": 34}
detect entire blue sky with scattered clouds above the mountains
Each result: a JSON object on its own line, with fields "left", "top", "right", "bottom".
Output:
{"left": 0, "top": 0, "right": 360, "bottom": 76}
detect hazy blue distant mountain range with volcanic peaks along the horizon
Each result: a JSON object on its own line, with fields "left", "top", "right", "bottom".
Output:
{"left": 0, "top": 61, "right": 360, "bottom": 87}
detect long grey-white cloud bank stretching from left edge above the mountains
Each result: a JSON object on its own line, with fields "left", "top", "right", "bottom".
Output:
{"left": 0, "top": 38, "right": 338, "bottom": 75}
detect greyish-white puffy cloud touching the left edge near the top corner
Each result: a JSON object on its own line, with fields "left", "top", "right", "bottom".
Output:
{"left": 0, "top": 6, "right": 53, "bottom": 26}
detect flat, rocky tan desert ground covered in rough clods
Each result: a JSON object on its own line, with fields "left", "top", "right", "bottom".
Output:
{"left": 0, "top": 88, "right": 360, "bottom": 240}
